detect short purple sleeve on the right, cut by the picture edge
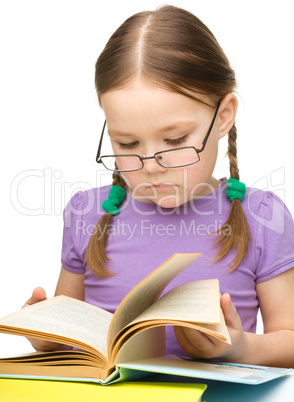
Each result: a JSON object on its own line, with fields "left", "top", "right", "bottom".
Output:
{"left": 253, "top": 191, "right": 294, "bottom": 283}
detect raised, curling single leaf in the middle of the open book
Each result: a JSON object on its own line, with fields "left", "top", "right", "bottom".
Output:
{"left": 107, "top": 253, "right": 201, "bottom": 350}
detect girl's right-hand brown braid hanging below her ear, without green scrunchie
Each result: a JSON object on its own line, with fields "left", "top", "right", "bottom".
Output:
{"left": 214, "top": 124, "right": 250, "bottom": 272}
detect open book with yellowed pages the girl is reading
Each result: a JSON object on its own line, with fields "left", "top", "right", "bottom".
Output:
{"left": 0, "top": 253, "right": 290, "bottom": 384}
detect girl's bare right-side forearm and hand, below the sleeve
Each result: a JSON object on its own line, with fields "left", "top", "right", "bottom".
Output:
{"left": 175, "top": 268, "right": 294, "bottom": 367}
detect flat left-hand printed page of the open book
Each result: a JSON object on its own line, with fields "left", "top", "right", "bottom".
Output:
{"left": 0, "top": 296, "right": 112, "bottom": 357}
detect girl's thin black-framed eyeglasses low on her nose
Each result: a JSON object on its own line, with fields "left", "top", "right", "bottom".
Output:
{"left": 96, "top": 99, "right": 222, "bottom": 172}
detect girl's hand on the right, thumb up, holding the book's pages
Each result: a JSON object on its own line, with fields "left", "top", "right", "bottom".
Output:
{"left": 175, "top": 293, "right": 246, "bottom": 362}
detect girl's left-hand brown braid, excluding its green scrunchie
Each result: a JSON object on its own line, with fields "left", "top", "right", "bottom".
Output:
{"left": 86, "top": 172, "right": 126, "bottom": 278}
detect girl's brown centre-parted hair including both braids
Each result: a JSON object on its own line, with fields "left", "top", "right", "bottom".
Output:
{"left": 87, "top": 6, "right": 250, "bottom": 276}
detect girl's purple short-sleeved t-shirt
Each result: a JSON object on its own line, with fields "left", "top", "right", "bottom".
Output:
{"left": 61, "top": 179, "right": 294, "bottom": 354}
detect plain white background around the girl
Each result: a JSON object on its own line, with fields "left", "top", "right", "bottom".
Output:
{"left": 0, "top": 0, "right": 294, "bottom": 356}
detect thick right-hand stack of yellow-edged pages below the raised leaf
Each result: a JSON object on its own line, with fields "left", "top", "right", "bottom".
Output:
{"left": 111, "top": 279, "right": 231, "bottom": 354}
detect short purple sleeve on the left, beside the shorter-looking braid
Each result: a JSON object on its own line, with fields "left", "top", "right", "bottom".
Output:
{"left": 61, "top": 192, "right": 85, "bottom": 273}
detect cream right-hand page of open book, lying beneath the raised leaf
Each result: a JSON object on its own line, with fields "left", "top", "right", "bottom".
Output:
{"left": 129, "top": 279, "right": 220, "bottom": 325}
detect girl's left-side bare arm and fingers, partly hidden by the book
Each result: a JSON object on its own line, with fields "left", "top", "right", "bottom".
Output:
{"left": 23, "top": 267, "right": 85, "bottom": 351}
